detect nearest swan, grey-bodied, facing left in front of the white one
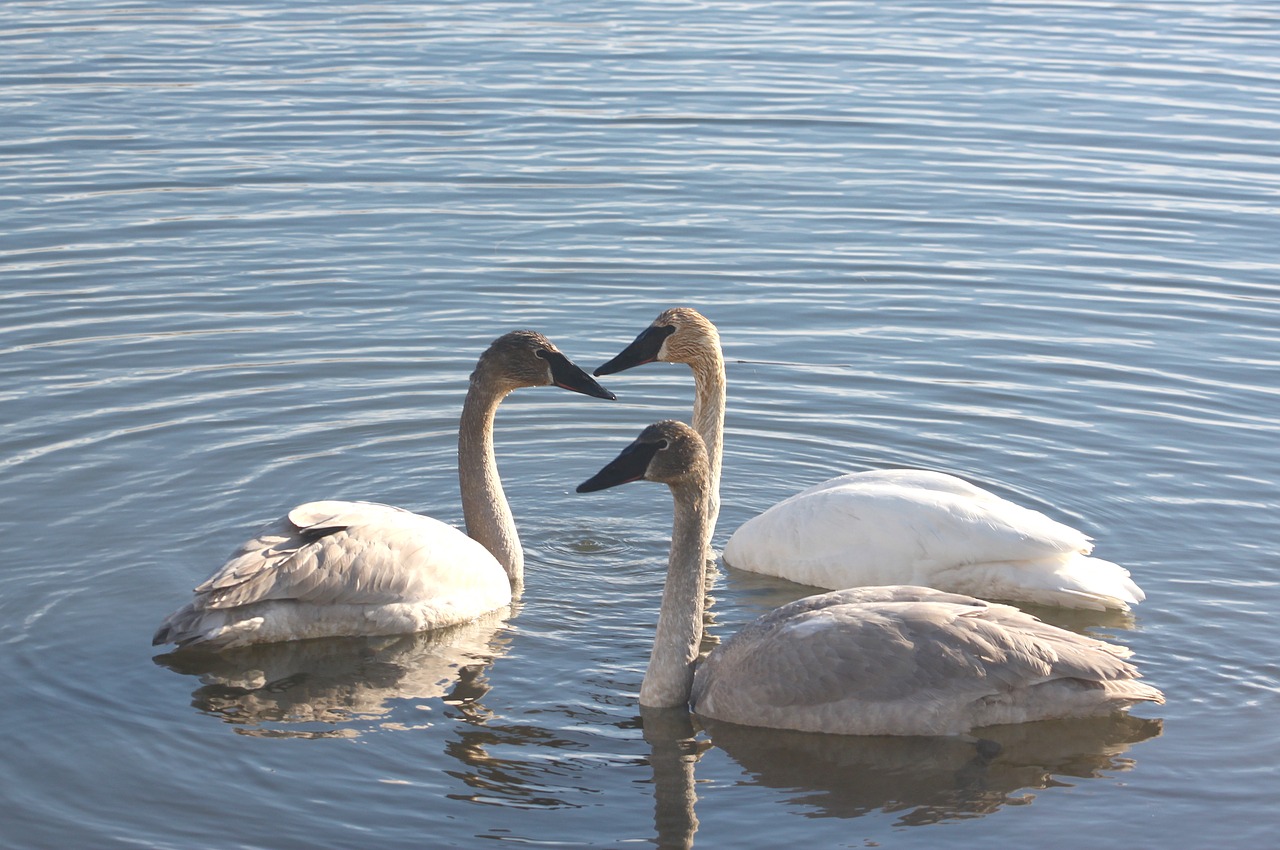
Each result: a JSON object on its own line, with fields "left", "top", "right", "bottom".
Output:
{"left": 577, "top": 421, "right": 1164, "bottom": 735}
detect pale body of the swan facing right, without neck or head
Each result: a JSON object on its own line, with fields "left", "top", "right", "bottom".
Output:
{"left": 152, "top": 501, "right": 511, "bottom": 649}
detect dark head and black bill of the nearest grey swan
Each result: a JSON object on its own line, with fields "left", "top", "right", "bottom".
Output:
{"left": 577, "top": 420, "right": 710, "bottom": 493}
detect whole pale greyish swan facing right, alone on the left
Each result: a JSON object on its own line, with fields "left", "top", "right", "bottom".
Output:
{"left": 151, "top": 330, "right": 616, "bottom": 650}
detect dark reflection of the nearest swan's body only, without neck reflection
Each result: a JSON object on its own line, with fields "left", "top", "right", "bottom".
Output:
{"left": 699, "top": 714, "right": 1162, "bottom": 826}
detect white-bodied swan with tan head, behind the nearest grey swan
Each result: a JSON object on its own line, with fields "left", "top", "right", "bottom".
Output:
{"left": 595, "top": 307, "right": 1146, "bottom": 611}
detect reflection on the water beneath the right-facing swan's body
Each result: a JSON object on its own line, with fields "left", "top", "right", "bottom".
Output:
{"left": 155, "top": 609, "right": 511, "bottom": 737}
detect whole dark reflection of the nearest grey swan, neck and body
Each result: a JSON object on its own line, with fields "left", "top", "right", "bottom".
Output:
{"left": 640, "top": 708, "right": 1162, "bottom": 850}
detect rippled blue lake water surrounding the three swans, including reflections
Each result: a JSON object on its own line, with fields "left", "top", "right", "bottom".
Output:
{"left": 0, "top": 0, "right": 1280, "bottom": 850}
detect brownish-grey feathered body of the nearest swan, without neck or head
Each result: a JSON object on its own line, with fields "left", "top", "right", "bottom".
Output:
{"left": 694, "top": 588, "right": 1162, "bottom": 734}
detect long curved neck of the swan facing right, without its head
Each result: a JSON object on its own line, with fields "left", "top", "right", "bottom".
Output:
{"left": 458, "top": 378, "right": 525, "bottom": 590}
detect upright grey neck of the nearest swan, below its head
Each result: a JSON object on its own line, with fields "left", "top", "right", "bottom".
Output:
{"left": 640, "top": 484, "right": 707, "bottom": 708}
